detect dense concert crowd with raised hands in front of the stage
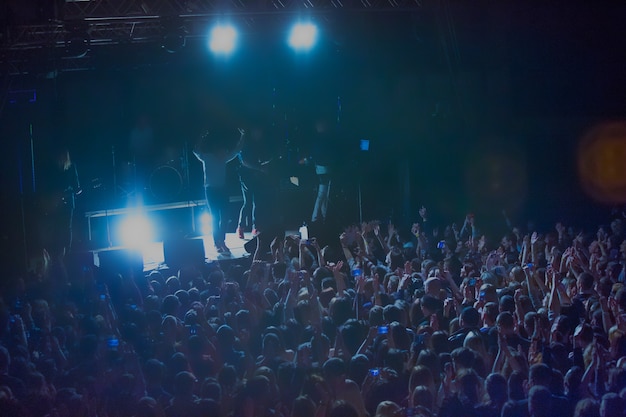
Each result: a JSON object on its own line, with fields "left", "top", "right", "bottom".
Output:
{"left": 0, "top": 208, "right": 626, "bottom": 417}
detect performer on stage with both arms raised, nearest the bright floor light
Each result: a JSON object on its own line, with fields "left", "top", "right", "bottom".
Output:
{"left": 193, "top": 129, "right": 245, "bottom": 255}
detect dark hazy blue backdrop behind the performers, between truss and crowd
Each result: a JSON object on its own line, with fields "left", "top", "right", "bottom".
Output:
{"left": 0, "top": 1, "right": 626, "bottom": 270}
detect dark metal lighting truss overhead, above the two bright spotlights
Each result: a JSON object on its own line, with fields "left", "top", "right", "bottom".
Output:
{"left": 0, "top": 0, "right": 422, "bottom": 76}
